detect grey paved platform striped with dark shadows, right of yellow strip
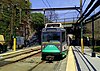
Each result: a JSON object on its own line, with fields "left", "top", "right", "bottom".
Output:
{"left": 73, "top": 46, "right": 100, "bottom": 71}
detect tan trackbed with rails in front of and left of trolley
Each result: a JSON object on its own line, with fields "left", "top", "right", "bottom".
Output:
{"left": 0, "top": 45, "right": 66, "bottom": 71}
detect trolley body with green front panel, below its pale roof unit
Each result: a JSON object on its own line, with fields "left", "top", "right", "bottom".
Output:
{"left": 41, "top": 28, "right": 67, "bottom": 60}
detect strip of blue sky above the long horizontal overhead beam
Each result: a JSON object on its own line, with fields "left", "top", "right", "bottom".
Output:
{"left": 30, "top": 0, "right": 80, "bottom": 8}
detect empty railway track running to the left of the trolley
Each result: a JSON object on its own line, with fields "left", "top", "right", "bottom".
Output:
{"left": 0, "top": 49, "right": 41, "bottom": 67}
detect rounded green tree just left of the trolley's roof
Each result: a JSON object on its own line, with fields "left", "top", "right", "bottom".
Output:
{"left": 31, "top": 13, "right": 44, "bottom": 44}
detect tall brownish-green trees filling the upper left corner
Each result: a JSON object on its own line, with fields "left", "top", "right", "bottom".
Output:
{"left": 0, "top": 0, "right": 31, "bottom": 41}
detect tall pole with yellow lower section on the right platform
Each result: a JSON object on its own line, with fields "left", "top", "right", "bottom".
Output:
{"left": 80, "top": 0, "right": 84, "bottom": 53}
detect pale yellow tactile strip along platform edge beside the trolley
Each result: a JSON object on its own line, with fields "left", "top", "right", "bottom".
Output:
{"left": 66, "top": 46, "right": 76, "bottom": 71}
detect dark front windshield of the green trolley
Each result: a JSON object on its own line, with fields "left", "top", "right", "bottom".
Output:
{"left": 42, "top": 32, "right": 60, "bottom": 42}
